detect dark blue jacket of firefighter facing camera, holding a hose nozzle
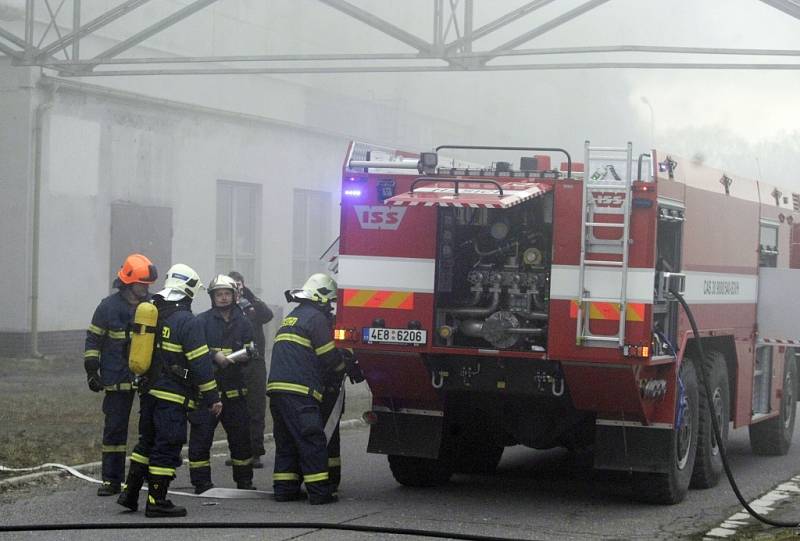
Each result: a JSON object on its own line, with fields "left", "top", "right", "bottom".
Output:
{"left": 197, "top": 305, "right": 253, "bottom": 398}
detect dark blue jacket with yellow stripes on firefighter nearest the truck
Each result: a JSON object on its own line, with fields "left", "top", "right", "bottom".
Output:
{"left": 267, "top": 301, "right": 345, "bottom": 402}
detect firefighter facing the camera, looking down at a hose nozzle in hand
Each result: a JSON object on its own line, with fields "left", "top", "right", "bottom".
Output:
{"left": 189, "top": 274, "right": 256, "bottom": 494}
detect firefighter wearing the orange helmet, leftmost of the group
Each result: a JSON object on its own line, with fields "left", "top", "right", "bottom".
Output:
{"left": 83, "top": 254, "right": 157, "bottom": 496}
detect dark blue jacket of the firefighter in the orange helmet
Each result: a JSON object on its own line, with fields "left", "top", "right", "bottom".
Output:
{"left": 83, "top": 291, "right": 136, "bottom": 391}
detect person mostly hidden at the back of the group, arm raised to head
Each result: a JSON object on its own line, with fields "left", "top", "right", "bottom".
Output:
{"left": 228, "top": 271, "right": 273, "bottom": 468}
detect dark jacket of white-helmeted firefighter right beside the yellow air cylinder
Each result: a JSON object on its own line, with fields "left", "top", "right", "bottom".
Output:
{"left": 145, "top": 296, "right": 219, "bottom": 409}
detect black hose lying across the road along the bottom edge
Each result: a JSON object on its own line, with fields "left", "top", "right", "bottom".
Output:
{"left": 0, "top": 522, "right": 535, "bottom": 541}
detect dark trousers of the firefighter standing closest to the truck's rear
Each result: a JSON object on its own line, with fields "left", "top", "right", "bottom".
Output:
{"left": 269, "top": 393, "right": 333, "bottom": 502}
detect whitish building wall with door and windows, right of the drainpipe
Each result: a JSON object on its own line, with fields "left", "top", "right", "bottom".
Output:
{"left": 33, "top": 82, "right": 347, "bottom": 331}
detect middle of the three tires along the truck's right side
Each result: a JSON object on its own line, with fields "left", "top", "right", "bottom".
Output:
{"left": 691, "top": 351, "right": 731, "bottom": 488}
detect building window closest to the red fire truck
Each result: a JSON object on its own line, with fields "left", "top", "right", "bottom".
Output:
{"left": 292, "top": 189, "right": 335, "bottom": 287}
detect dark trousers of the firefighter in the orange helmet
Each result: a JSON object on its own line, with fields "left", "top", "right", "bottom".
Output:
{"left": 103, "top": 385, "right": 136, "bottom": 484}
